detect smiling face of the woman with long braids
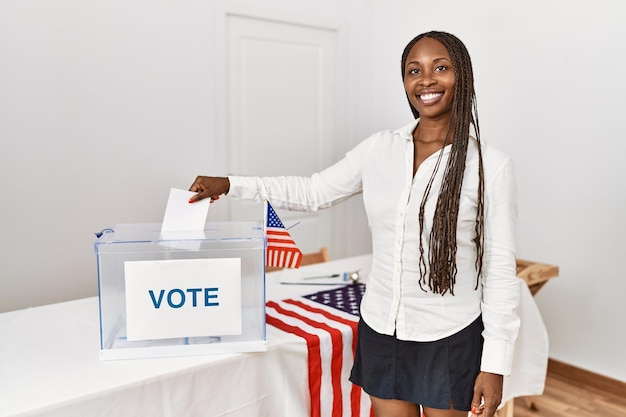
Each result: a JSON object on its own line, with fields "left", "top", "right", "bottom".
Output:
{"left": 404, "top": 37, "right": 455, "bottom": 120}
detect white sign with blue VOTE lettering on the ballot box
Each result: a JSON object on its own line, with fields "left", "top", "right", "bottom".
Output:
{"left": 124, "top": 258, "right": 242, "bottom": 341}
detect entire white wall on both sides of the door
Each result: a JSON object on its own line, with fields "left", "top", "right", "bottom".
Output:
{"left": 0, "top": 0, "right": 626, "bottom": 381}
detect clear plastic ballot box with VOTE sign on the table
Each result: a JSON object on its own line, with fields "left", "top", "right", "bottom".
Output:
{"left": 94, "top": 222, "right": 267, "bottom": 360}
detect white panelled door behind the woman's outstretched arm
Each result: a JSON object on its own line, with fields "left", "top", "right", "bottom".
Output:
{"left": 226, "top": 15, "right": 338, "bottom": 253}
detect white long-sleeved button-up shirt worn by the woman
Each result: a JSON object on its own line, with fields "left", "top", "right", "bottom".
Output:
{"left": 228, "top": 120, "right": 519, "bottom": 375}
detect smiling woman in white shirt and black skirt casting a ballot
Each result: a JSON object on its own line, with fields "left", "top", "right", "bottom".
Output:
{"left": 190, "top": 32, "right": 519, "bottom": 417}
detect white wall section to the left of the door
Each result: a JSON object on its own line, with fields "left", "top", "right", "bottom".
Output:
{"left": 0, "top": 0, "right": 215, "bottom": 310}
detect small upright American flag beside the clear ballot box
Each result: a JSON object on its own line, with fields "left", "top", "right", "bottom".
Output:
{"left": 265, "top": 201, "right": 302, "bottom": 268}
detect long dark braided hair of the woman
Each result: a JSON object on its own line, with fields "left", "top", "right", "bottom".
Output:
{"left": 402, "top": 31, "right": 485, "bottom": 295}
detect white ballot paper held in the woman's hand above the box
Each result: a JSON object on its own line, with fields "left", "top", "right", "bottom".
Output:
{"left": 161, "top": 188, "right": 211, "bottom": 232}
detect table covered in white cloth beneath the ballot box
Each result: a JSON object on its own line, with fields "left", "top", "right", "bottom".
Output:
{"left": 0, "top": 255, "right": 547, "bottom": 417}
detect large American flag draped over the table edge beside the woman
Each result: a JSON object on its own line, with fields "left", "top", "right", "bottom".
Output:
{"left": 266, "top": 284, "right": 374, "bottom": 417}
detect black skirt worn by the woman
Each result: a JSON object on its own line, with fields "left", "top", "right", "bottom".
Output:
{"left": 350, "top": 316, "right": 483, "bottom": 411}
